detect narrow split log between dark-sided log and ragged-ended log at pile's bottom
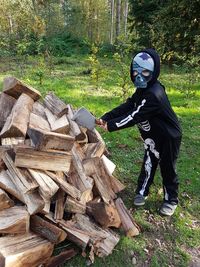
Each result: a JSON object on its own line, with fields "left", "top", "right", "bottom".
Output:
{"left": 59, "top": 220, "right": 90, "bottom": 250}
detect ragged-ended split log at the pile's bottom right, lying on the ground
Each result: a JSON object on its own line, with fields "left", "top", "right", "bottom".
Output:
{"left": 73, "top": 214, "right": 120, "bottom": 257}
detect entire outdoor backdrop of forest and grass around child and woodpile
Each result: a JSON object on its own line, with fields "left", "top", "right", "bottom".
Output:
{"left": 0, "top": 0, "right": 200, "bottom": 267}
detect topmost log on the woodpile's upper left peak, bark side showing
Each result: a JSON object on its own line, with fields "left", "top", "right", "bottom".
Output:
{"left": 3, "top": 77, "right": 41, "bottom": 100}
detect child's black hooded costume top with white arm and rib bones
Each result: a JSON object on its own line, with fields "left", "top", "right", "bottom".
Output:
{"left": 101, "top": 49, "right": 181, "bottom": 143}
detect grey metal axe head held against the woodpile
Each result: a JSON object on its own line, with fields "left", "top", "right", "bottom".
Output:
{"left": 72, "top": 107, "right": 96, "bottom": 130}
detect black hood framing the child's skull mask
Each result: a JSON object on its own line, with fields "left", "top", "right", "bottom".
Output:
{"left": 130, "top": 48, "right": 160, "bottom": 88}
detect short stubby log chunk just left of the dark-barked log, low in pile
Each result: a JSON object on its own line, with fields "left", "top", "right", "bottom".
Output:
{"left": 65, "top": 196, "right": 86, "bottom": 214}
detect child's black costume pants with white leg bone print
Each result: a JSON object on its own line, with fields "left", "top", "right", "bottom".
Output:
{"left": 136, "top": 138, "right": 181, "bottom": 203}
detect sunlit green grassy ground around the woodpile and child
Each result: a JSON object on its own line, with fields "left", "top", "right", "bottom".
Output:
{"left": 0, "top": 56, "right": 200, "bottom": 267}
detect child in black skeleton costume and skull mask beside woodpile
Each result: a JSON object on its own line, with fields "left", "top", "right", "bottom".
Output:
{"left": 100, "top": 49, "right": 181, "bottom": 215}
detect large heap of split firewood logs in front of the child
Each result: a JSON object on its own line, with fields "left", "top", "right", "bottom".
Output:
{"left": 0, "top": 77, "right": 139, "bottom": 267}
